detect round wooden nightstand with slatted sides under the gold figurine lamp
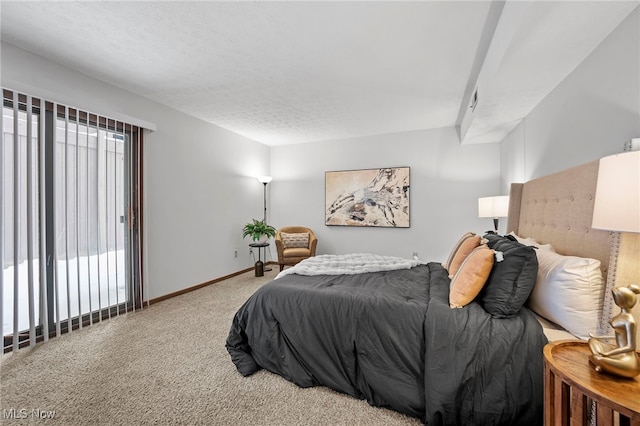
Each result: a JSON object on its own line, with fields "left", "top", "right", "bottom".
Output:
{"left": 544, "top": 340, "right": 640, "bottom": 426}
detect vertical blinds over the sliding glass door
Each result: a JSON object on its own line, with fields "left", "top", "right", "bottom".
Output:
{"left": 0, "top": 89, "right": 144, "bottom": 352}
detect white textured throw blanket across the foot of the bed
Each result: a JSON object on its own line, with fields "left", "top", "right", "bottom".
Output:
{"left": 276, "top": 253, "right": 421, "bottom": 279}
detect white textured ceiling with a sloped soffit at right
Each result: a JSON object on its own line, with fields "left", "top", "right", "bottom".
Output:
{"left": 0, "top": 1, "right": 639, "bottom": 145}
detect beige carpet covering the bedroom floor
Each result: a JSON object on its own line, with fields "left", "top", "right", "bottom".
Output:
{"left": 0, "top": 268, "right": 420, "bottom": 425}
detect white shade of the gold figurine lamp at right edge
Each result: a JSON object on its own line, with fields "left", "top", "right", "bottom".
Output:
{"left": 591, "top": 151, "right": 640, "bottom": 232}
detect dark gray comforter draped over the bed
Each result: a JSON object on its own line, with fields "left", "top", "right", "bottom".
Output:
{"left": 226, "top": 263, "right": 547, "bottom": 425}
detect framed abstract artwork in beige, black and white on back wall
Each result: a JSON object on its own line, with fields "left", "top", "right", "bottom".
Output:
{"left": 325, "top": 167, "right": 410, "bottom": 228}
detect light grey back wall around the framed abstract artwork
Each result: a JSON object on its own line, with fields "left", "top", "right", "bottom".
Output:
{"left": 269, "top": 127, "right": 502, "bottom": 261}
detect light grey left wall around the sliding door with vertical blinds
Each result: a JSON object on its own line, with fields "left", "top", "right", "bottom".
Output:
{"left": 2, "top": 43, "right": 269, "bottom": 298}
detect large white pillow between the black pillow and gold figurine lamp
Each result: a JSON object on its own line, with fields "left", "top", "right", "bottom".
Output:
{"left": 529, "top": 250, "right": 604, "bottom": 340}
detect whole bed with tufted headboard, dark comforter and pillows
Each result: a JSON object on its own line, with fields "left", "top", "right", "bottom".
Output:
{"left": 226, "top": 162, "right": 624, "bottom": 425}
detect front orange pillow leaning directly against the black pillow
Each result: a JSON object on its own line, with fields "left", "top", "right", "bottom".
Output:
{"left": 449, "top": 244, "right": 495, "bottom": 308}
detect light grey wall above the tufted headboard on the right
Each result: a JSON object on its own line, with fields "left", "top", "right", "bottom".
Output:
{"left": 501, "top": 8, "right": 640, "bottom": 190}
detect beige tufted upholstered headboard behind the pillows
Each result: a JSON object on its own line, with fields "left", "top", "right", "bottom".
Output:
{"left": 507, "top": 161, "right": 640, "bottom": 348}
